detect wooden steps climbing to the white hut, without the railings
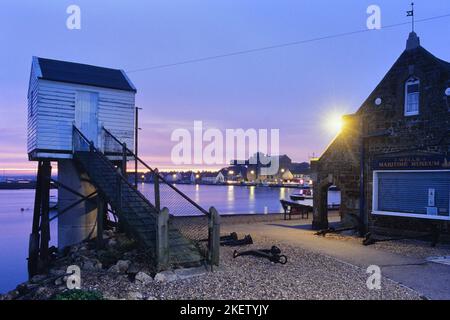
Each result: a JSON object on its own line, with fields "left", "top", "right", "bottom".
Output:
{"left": 73, "top": 150, "right": 204, "bottom": 267}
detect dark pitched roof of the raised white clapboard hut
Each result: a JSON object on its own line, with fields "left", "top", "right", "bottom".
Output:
{"left": 37, "top": 58, "right": 136, "bottom": 92}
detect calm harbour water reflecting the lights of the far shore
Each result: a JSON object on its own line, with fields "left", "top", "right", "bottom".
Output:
{"left": 0, "top": 184, "right": 340, "bottom": 292}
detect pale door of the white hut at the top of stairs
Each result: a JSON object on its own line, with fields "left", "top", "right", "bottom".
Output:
{"left": 75, "top": 91, "right": 98, "bottom": 146}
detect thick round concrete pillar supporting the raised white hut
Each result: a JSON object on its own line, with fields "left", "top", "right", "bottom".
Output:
{"left": 58, "top": 160, "right": 97, "bottom": 250}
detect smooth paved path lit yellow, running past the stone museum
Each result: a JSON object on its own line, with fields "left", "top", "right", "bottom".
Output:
{"left": 222, "top": 218, "right": 450, "bottom": 299}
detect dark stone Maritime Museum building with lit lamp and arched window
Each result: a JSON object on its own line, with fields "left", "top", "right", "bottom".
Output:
{"left": 311, "top": 32, "right": 450, "bottom": 234}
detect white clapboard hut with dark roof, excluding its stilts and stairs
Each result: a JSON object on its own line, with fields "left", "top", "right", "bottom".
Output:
{"left": 28, "top": 57, "right": 136, "bottom": 160}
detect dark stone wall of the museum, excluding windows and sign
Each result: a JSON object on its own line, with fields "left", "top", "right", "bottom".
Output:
{"left": 312, "top": 38, "right": 450, "bottom": 236}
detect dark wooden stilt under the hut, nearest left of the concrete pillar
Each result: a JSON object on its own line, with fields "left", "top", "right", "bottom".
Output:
{"left": 40, "top": 161, "right": 52, "bottom": 269}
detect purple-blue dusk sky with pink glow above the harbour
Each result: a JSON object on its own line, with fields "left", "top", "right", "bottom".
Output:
{"left": 0, "top": 0, "right": 450, "bottom": 172}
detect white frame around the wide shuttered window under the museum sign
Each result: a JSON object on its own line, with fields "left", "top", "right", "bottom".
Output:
{"left": 372, "top": 170, "right": 450, "bottom": 221}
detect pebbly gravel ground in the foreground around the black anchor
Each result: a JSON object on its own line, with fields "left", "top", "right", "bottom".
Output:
{"left": 84, "top": 238, "right": 419, "bottom": 300}
